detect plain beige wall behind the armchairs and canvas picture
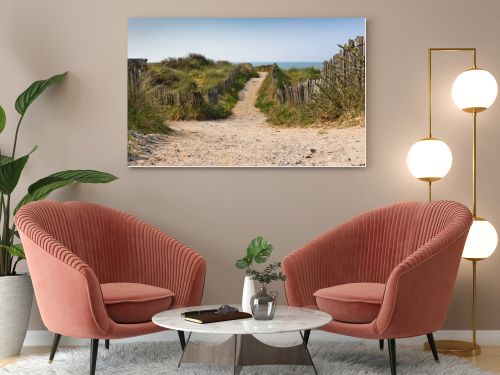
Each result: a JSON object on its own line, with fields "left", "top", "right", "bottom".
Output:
{"left": 0, "top": 0, "right": 500, "bottom": 329}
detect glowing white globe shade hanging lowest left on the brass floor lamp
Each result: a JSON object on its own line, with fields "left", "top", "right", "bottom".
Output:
{"left": 406, "top": 138, "right": 453, "bottom": 181}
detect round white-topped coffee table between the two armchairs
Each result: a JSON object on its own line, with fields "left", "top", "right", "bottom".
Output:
{"left": 153, "top": 306, "right": 332, "bottom": 374}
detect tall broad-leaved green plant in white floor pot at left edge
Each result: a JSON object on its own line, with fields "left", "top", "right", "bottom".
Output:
{"left": 0, "top": 73, "right": 116, "bottom": 358}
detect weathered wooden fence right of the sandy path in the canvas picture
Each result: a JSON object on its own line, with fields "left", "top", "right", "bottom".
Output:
{"left": 270, "top": 36, "right": 365, "bottom": 105}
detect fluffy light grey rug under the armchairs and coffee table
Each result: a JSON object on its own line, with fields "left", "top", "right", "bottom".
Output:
{"left": 0, "top": 342, "right": 492, "bottom": 375}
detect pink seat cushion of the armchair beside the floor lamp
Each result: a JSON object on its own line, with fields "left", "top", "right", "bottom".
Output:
{"left": 314, "top": 283, "right": 385, "bottom": 323}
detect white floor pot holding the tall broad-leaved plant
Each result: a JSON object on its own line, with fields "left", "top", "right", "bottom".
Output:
{"left": 0, "top": 275, "right": 33, "bottom": 358}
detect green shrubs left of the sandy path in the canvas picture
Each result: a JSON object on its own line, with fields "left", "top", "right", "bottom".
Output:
{"left": 129, "top": 54, "right": 258, "bottom": 122}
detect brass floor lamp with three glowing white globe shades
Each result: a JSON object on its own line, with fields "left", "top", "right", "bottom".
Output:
{"left": 407, "top": 48, "right": 498, "bottom": 356}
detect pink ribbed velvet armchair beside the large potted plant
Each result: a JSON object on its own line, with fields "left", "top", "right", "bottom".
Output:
{"left": 16, "top": 201, "right": 206, "bottom": 375}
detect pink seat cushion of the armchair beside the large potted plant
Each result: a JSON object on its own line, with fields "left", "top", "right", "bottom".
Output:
{"left": 101, "top": 283, "right": 174, "bottom": 323}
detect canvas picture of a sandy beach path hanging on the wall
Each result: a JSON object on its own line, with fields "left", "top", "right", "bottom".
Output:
{"left": 127, "top": 18, "right": 366, "bottom": 167}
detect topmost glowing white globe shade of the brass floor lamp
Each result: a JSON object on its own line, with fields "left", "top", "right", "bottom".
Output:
{"left": 451, "top": 69, "right": 498, "bottom": 112}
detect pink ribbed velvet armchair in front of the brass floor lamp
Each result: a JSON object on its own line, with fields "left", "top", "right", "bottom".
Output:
{"left": 283, "top": 201, "right": 472, "bottom": 375}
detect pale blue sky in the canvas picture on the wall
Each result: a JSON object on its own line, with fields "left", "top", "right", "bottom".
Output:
{"left": 128, "top": 18, "right": 365, "bottom": 62}
